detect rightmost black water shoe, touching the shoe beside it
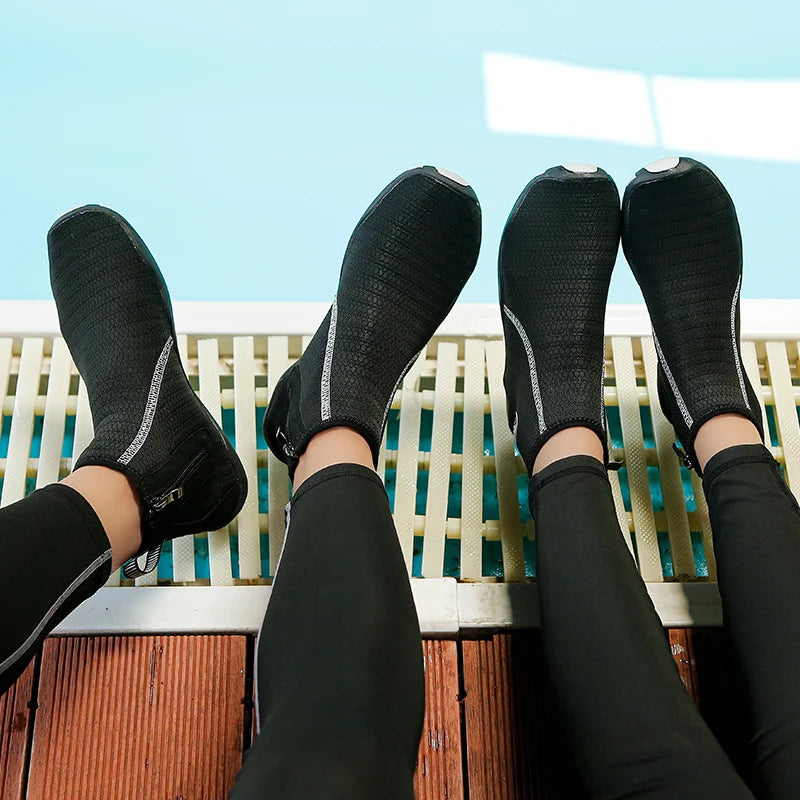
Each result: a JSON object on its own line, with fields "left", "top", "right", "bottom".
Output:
{"left": 622, "top": 158, "right": 763, "bottom": 463}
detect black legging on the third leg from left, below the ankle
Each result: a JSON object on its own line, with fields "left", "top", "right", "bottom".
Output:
{"left": 530, "top": 456, "right": 751, "bottom": 798}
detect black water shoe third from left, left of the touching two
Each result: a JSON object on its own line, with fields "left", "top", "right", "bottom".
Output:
{"left": 498, "top": 167, "right": 620, "bottom": 473}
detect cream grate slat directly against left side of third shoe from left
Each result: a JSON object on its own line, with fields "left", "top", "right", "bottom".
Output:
{"left": 486, "top": 339, "right": 525, "bottom": 581}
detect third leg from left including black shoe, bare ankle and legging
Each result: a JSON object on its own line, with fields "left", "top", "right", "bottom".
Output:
{"left": 499, "top": 165, "right": 751, "bottom": 798}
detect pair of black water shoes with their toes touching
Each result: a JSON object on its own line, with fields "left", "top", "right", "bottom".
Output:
{"left": 499, "top": 158, "right": 763, "bottom": 473}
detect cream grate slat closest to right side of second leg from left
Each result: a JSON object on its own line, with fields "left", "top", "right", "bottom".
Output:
{"left": 394, "top": 351, "right": 426, "bottom": 575}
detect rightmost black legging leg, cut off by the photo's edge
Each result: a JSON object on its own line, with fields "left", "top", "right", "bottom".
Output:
{"left": 703, "top": 445, "right": 800, "bottom": 799}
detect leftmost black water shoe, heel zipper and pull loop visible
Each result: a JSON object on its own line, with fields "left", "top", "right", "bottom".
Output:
{"left": 47, "top": 206, "right": 247, "bottom": 577}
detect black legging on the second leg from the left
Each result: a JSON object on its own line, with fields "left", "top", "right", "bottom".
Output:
{"left": 231, "top": 464, "right": 425, "bottom": 800}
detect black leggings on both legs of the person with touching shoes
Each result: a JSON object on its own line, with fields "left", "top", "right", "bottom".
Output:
{"left": 530, "top": 445, "right": 800, "bottom": 798}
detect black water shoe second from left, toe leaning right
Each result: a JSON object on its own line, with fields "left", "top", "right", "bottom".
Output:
{"left": 264, "top": 167, "right": 481, "bottom": 468}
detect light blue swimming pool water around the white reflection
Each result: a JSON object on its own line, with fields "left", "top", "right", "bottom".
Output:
{"left": 0, "top": 0, "right": 800, "bottom": 302}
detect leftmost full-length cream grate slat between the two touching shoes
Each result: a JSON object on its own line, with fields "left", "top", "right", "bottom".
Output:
{"left": 611, "top": 336, "right": 664, "bottom": 581}
